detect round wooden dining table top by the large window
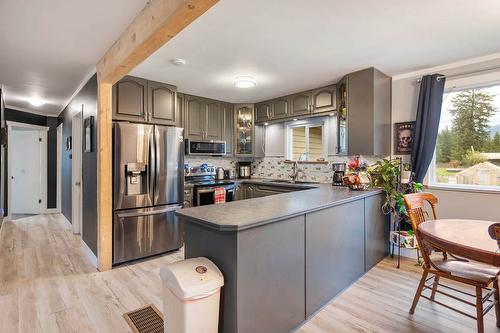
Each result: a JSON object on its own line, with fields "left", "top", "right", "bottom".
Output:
{"left": 418, "top": 219, "right": 500, "bottom": 267}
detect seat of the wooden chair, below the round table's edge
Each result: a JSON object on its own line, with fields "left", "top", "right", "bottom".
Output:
{"left": 432, "top": 259, "right": 500, "bottom": 283}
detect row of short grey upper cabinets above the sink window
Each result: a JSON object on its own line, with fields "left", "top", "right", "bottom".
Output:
{"left": 255, "top": 85, "right": 337, "bottom": 123}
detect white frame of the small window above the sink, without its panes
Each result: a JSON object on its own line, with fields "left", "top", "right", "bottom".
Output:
{"left": 285, "top": 117, "right": 329, "bottom": 163}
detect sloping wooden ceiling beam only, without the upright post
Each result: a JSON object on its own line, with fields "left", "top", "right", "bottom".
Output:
{"left": 97, "top": 0, "right": 218, "bottom": 84}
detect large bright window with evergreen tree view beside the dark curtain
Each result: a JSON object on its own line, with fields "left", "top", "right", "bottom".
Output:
{"left": 429, "top": 85, "right": 500, "bottom": 190}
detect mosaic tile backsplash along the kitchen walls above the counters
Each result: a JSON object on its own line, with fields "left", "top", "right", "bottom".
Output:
{"left": 185, "top": 156, "right": 379, "bottom": 183}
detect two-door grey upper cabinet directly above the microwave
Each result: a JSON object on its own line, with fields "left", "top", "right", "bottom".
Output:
{"left": 184, "top": 95, "right": 224, "bottom": 141}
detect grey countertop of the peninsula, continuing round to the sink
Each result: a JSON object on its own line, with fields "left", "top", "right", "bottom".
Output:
{"left": 177, "top": 179, "right": 382, "bottom": 231}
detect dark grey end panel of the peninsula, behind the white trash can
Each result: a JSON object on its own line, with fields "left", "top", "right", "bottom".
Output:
{"left": 184, "top": 217, "right": 238, "bottom": 333}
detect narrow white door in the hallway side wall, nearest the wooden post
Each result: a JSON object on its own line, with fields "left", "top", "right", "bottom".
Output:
{"left": 71, "top": 109, "right": 83, "bottom": 235}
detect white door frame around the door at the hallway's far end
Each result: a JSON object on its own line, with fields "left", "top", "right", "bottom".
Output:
{"left": 6, "top": 120, "right": 49, "bottom": 220}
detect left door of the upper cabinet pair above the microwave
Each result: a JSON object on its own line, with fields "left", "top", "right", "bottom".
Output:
{"left": 184, "top": 95, "right": 206, "bottom": 140}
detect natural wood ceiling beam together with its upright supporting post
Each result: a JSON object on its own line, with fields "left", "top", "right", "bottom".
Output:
{"left": 97, "top": 0, "right": 218, "bottom": 271}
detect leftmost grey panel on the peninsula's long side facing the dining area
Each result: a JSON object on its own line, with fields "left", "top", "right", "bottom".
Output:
{"left": 237, "top": 215, "right": 305, "bottom": 333}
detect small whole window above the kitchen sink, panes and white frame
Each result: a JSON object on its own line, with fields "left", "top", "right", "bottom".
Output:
{"left": 287, "top": 119, "right": 328, "bottom": 161}
